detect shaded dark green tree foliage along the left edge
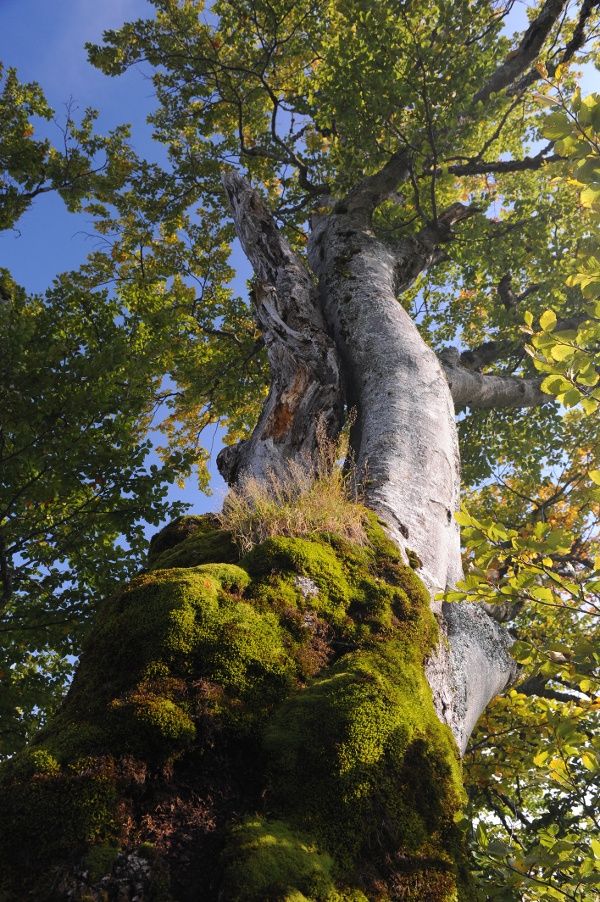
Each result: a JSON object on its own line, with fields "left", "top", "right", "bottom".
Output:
{"left": 0, "top": 67, "right": 196, "bottom": 757}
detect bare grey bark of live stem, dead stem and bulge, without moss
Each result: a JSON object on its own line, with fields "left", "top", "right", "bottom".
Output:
{"left": 219, "top": 173, "right": 515, "bottom": 751}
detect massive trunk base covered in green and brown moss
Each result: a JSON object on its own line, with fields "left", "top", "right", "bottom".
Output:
{"left": 0, "top": 517, "right": 473, "bottom": 902}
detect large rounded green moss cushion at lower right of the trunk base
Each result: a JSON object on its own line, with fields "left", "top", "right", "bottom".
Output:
{"left": 265, "top": 641, "right": 462, "bottom": 867}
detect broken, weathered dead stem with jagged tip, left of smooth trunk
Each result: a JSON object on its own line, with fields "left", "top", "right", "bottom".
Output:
{"left": 217, "top": 171, "right": 343, "bottom": 484}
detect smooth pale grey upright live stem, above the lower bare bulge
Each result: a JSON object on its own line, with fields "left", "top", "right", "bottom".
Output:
{"left": 308, "top": 208, "right": 462, "bottom": 591}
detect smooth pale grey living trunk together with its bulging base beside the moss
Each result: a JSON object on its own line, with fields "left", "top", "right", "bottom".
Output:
{"left": 309, "top": 213, "right": 516, "bottom": 753}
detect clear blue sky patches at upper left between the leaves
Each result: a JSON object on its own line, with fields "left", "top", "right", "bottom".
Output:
{"left": 0, "top": 0, "right": 156, "bottom": 291}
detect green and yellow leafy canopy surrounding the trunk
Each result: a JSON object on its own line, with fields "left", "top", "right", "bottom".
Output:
{"left": 0, "top": 0, "right": 600, "bottom": 900}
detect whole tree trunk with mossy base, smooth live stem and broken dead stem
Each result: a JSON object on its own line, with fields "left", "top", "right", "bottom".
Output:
{"left": 0, "top": 173, "right": 515, "bottom": 902}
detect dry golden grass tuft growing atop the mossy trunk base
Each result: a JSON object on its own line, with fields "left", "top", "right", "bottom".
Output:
{"left": 218, "top": 428, "right": 367, "bottom": 553}
